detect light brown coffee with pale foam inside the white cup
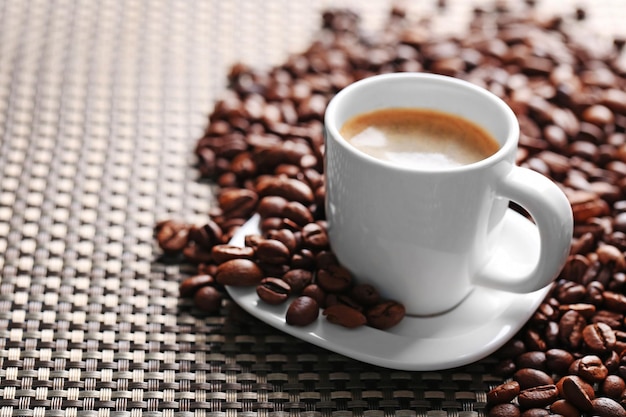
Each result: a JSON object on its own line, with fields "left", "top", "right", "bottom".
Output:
{"left": 340, "top": 108, "right": 499, "bottom": 169}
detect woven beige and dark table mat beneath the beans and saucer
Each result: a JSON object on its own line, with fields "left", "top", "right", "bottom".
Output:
{"left": 0, "top": 0, "right": 626, "bottom": 417}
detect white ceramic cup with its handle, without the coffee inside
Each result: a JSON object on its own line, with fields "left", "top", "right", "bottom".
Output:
{"left": 324, "top": 73, "right": 573, "bottom": 316}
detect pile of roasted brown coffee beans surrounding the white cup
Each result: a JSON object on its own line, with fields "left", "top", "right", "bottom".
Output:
{"left": 156, "top": 0, "right": 626, "bottom": 417}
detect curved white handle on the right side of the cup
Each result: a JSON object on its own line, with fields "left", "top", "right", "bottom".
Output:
{"left": 474, "top": 166, "right": 574, "bottom": 293}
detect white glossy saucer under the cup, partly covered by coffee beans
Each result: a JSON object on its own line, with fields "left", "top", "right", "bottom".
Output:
{"left": 227, "top": 210, "right": 550, "bottom": 371}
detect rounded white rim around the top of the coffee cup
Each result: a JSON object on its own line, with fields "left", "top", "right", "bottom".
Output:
{"left": 324, "top": 72, "right": 520, "bottom": 175}
